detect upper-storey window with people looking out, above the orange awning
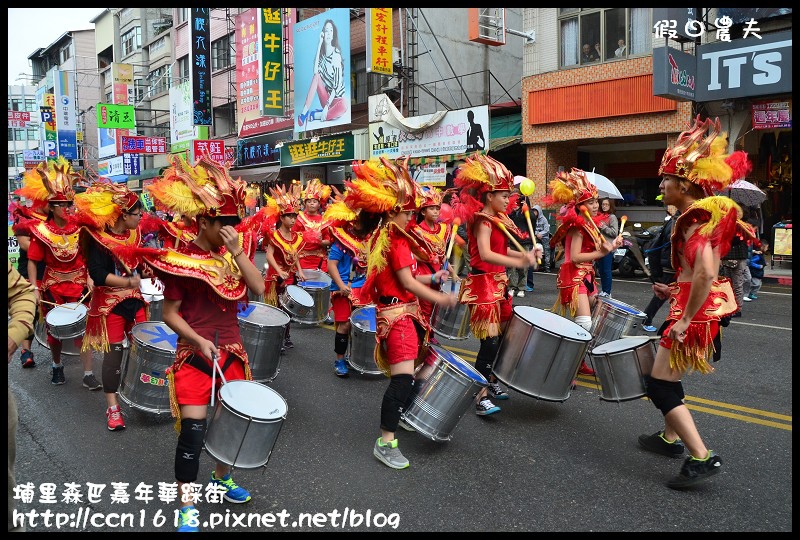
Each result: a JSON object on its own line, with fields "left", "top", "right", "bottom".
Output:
{"left": 558, "top": 8, "right": 653, "bottom": 67}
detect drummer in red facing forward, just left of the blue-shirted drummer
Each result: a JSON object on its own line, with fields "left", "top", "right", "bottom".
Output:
{"left": 292, "top": 178, "right": 331, "bottom": 272}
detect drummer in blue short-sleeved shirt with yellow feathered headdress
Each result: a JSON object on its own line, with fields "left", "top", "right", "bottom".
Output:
{"left": 323, "top": 188, "right": 380, "bottom": 377}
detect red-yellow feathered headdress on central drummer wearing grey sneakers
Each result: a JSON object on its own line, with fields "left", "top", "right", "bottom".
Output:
{"left": 345, "top": 157, "right": 419, "bottom": 214}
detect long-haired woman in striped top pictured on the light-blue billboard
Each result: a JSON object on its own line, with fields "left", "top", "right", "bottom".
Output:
{"left": 297, "top": 19, "right": 347, "bottom": 128}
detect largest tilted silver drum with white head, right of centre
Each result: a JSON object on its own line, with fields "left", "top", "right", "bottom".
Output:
{"left": 492, "top": 306, "right": 592, "bottom": 401}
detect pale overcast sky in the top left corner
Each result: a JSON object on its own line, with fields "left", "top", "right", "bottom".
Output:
{"left": 7, "top": 7, "right": 104, "bottom": 85}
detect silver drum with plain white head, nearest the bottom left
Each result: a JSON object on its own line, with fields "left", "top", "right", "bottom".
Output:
{"left": 205, "top": 381, "right": 288, "bottom": 469}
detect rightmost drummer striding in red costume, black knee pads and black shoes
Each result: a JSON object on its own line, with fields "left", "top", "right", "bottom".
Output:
{"left": 639, "top": 115, "right": 754, "bottom": 489}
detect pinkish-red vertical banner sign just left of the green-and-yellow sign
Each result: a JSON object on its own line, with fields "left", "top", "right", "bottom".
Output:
{"left": 235, "top": 8, "right": 261, "bottom": 121}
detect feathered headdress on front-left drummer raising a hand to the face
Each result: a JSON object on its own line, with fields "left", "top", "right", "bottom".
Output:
{"left": 146, "top": 155, "right": 247, "bottom": 219}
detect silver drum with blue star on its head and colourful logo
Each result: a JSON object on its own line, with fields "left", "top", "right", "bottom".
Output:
{"left": 119, "top": 321, "right": 178, "bottom": 414}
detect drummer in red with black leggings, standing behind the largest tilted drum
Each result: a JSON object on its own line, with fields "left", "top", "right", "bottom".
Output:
{"left": 454, "top": 154, "right": 541, "bottom": 416}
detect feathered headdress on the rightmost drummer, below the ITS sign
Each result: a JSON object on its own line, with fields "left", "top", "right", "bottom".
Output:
{"left": 658, "top": 115, "right": 752, "bottom": 195}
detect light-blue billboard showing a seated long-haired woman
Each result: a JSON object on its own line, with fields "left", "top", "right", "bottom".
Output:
{"left": 294, "top": 8, "right": 352, "bottom": 133}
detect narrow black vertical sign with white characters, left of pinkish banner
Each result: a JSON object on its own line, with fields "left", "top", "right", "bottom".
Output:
{"left": 189, "top": 8, "right": 211, "bottom": 126}
